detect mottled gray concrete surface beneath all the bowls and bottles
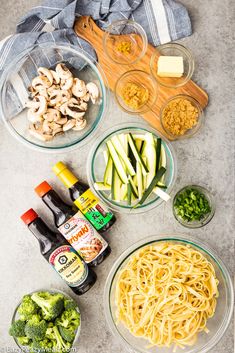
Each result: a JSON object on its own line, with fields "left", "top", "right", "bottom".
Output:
{"left": 0, "top": 0, "right": 235, "bottom": 353}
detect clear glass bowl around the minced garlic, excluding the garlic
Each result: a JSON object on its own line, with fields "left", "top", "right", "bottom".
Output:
{"left": 114, "top": 70, "right": 158, "bottom": 114}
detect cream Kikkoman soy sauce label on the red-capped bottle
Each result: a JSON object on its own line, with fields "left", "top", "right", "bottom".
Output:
{"left": 49, "top": 245, "right": 88, "bottom": 287}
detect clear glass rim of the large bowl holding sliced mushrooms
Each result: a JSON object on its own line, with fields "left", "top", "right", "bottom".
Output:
{"left": 0, "top": 42, "right": 109, "bottom": 153}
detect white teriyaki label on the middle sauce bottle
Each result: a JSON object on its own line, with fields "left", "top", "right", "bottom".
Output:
{"left": 59, "top": 211, "right": 108, "bottom": 264}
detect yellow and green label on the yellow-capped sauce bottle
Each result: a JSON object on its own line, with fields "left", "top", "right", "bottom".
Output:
{"left": 74, "top": 189, "right": 113, "bottom": 230}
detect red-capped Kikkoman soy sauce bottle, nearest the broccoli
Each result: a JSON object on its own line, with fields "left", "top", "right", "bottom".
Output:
{"left": 21, "top": 208, "right": 96, "bottom": 295}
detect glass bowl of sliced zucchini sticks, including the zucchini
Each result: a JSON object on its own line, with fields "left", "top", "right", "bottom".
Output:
{"left": 87, "top": 123, "right": 176, "bottom": 213}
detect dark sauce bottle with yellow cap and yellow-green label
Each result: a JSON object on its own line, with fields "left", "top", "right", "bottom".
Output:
{"left": 52, "top": 162, "right": 116, "bottom": 233}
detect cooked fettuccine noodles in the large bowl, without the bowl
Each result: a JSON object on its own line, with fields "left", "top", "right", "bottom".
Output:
{"left": 115, "top": 242, "right": 219, "bottom": 348}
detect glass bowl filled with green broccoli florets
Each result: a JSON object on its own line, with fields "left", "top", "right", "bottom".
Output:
{"left": 9, "top": 289, "right": 81, "bottom": 353}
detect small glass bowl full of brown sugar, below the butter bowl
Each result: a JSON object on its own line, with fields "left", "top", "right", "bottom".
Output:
{"left": 160, "top": 94, "right": 204, "bottom": 139}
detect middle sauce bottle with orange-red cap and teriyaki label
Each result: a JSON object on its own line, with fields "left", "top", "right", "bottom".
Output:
{"left": 35, "top": 181, "right": 111, "bottom": 266}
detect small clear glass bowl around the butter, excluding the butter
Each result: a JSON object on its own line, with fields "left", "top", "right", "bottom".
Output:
{"left": 150, "top": 43, "right": 194, "bottom": 88}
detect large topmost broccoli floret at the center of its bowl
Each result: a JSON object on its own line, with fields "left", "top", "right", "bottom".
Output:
{"left": 32, "top": 292, "right": 64, "bottom": 321}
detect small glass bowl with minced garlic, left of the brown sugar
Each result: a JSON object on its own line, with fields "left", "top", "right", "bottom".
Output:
{"left": 114, "top": 70, "right": 157, "bottom": 114}
